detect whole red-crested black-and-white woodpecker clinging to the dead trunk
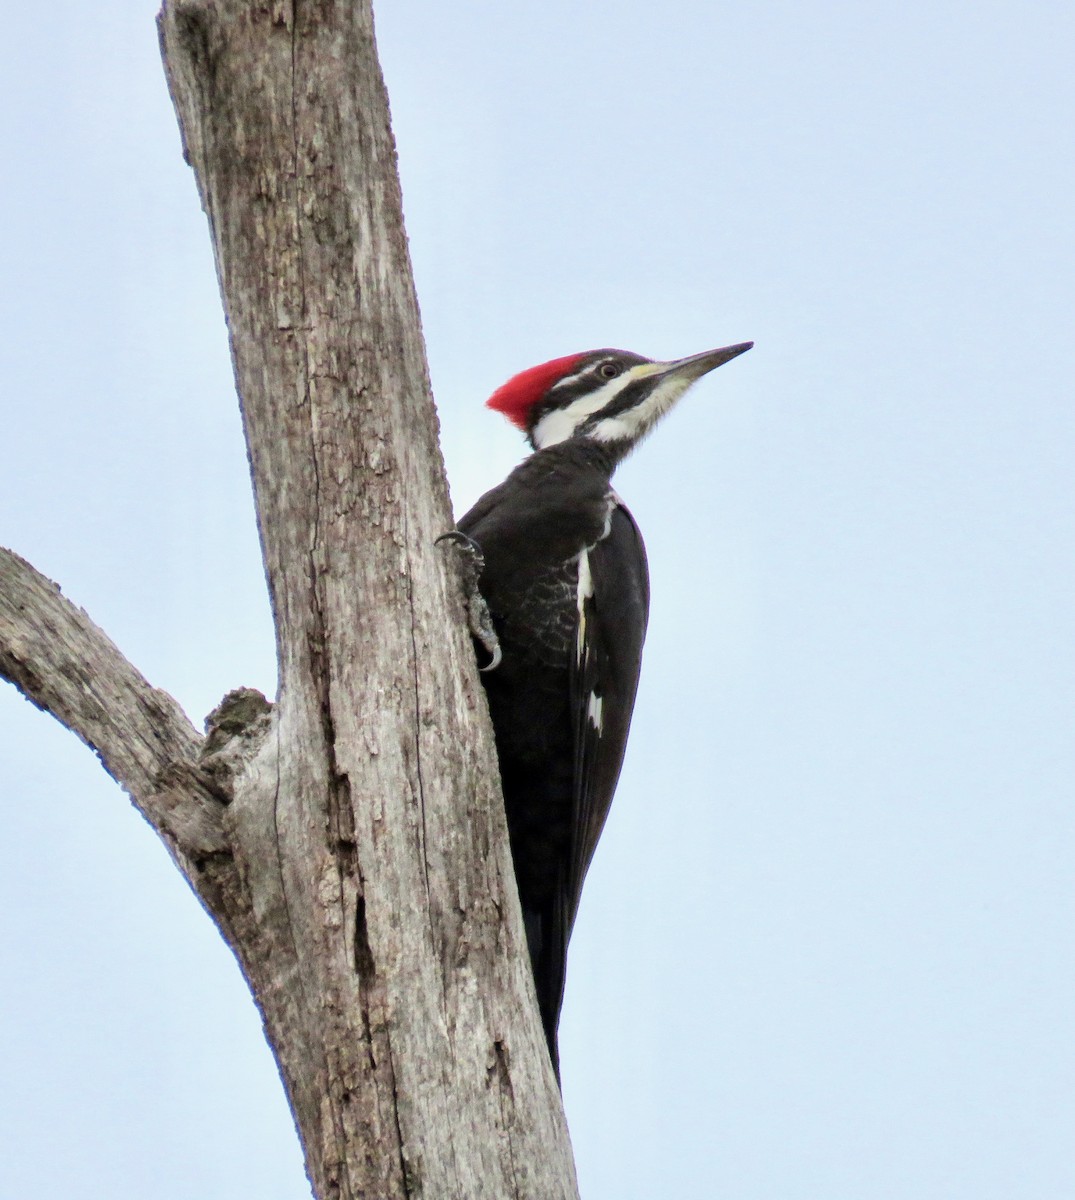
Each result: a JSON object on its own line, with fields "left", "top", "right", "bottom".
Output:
{"left": 446, "top": 342, "right": 753, "bottom": 1076}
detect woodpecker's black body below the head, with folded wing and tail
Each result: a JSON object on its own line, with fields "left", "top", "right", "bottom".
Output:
{"left": 458, "top": 438, "right": 649, "bottom": 1080}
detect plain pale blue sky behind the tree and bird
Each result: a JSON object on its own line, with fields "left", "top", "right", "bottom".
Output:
{"left": 0, "top": 0, "right": 1075, "bottom": 1200}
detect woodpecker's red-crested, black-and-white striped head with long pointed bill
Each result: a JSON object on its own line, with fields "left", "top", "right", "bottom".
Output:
{"left": 486, "top": 342, "right": 753, "bottom": 456}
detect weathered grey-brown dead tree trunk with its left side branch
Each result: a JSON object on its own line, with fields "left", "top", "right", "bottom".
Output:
{"left": 0, "top": 0, "right": 577, "bottom": 1200}
